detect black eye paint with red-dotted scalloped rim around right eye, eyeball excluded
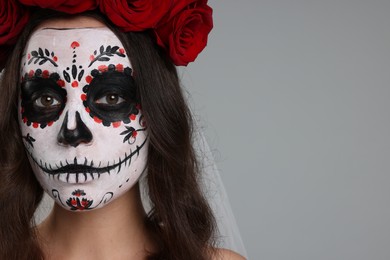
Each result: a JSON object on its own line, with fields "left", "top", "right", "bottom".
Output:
{"left": 81, "top": 64, "right": 140, "bottom": 127}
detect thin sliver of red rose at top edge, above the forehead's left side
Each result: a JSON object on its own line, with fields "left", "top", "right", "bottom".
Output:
{"left": 19, "top": 0, "right": 97, "bottom": 14}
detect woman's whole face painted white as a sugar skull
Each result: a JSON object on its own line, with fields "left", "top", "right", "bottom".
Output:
{"left": 19, "top": 28, "right": 148, "bottom": 211}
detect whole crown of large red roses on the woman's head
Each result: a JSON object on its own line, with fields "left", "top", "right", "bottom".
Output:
{"left": 0, "top": 0, "right": 213, "bottom": 71}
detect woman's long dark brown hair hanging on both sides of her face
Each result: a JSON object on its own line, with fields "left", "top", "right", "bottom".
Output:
{"left": 0, "top": 10, "right": 215, "bottom": 260}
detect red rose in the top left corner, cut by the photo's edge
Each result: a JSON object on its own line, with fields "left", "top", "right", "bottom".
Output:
{"left": 0, "top": 0, "right": 29, "bottom": 45}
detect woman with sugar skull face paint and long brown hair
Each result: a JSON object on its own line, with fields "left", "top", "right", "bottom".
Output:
{"left": 0, "top": 1, "right": 242, "bottom": 259}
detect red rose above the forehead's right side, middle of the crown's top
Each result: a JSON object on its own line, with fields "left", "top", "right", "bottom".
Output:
{"left": 98, "top": 0, "right": 172, "bottom": 32}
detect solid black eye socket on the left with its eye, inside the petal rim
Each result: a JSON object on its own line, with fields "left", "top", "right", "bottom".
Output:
{"left": 21, "top": 78, "right": 66, "bottom": 126}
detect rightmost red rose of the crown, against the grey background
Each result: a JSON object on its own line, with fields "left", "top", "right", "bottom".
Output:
{"left": 154, "top": 0, "right": 213, "bottom": 66}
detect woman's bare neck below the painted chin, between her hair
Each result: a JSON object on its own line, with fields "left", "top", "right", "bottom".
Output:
{"left": 38, "top": 185, "right": 153, "bottom": 260}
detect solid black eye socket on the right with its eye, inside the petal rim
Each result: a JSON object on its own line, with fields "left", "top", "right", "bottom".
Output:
{"left": 84, "top": 70, "right": 138, "bottom": 125}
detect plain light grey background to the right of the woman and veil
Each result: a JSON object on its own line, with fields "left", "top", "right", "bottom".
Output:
{"left": 181, "top": 0, "right": 390, "bottom": 260}
